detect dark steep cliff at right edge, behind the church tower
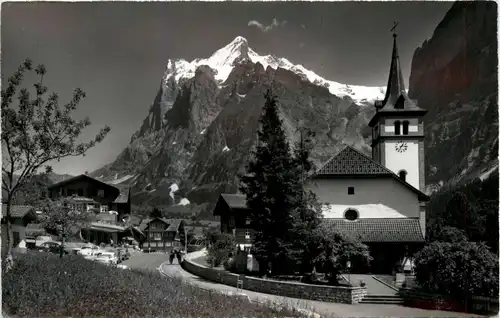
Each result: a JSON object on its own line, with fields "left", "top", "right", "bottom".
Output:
{"left": 409, "top": 1, "right": 498, "bottom": 190}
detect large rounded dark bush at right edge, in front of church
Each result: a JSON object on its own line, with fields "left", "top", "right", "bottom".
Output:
{"left": 415, "top": 241, "right": 498, "bottom": 299}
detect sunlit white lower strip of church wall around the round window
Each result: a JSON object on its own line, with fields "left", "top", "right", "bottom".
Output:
{"left": 322, "top": 204, "right": 406, "bottom": 219}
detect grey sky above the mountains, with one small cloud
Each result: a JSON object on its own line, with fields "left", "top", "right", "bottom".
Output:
{"left": 1, "top": 1, "right": 452, "bottom": 175}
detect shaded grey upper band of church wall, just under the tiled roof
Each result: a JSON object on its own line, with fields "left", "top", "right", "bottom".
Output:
{"left": 307, "top": 178, "right": 420, "bottom": 217}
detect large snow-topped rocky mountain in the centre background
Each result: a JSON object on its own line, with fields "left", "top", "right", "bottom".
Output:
{"left": 92, "top": 37, "right": 384, "bottom": 214}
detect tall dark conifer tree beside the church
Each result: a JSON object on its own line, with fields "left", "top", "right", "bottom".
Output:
{"left": 240, "top": 90, "right": 302, "bottom": 273}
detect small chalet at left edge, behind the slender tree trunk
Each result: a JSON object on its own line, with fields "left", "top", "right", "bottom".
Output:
{"left": 2, "top": 204, "right": 37, "bottom": 251}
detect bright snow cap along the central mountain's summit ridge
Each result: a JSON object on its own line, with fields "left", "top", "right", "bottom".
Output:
{"left": 164, "top": 36, "right": 385, "bottom": 103}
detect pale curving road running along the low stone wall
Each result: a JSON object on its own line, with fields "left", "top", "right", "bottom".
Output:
{"left": 123, "top": 253, "right": 480, "bottom": 317}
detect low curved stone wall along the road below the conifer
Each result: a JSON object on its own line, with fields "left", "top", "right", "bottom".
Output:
{"left": 181, "top": 259, "right": 366, "bottom": 304}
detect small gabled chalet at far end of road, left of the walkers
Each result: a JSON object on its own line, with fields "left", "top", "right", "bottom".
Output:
{"left": 139, "top": 218, "right": 185, "bottom": 252}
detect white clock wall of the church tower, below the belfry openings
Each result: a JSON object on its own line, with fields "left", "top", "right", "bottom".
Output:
{"left": 383, "top": 139, "right": 420, "bottom": 189}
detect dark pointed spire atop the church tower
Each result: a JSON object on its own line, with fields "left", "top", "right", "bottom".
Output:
{"left": 383, "top": 22, "right": 406, "bottom": 107}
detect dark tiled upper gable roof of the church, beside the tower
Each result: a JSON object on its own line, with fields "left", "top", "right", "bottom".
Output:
{"left": 313, "top": 145, "right": 429, "bottom": 201}
